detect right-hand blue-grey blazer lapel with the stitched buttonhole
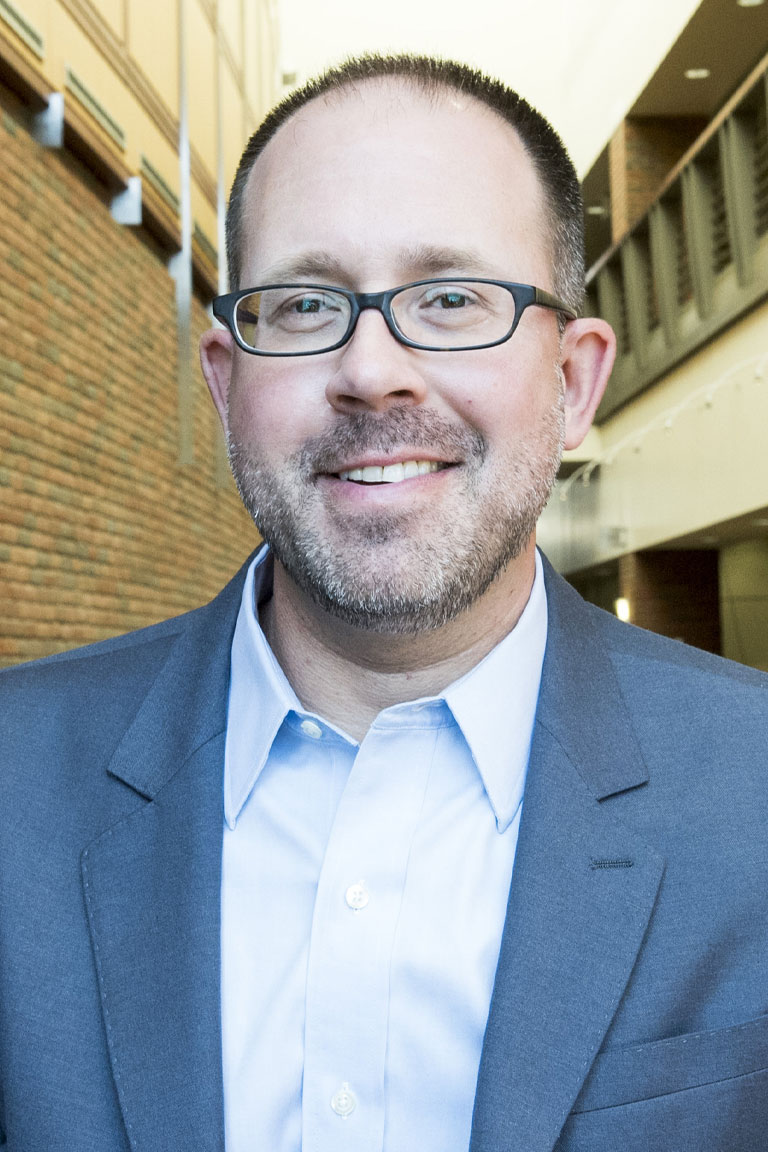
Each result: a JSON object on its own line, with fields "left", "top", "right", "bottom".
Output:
{"left": 470, "top": 569, "right": 663, "bottom": 1152}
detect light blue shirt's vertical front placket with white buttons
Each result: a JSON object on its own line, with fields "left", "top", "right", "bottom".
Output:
{"left": 302, "top": 730, "right": 435, "bottom": 1152}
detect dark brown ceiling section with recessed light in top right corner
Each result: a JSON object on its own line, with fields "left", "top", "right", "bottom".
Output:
{"left": 630, "top": 0, "right": 768, "bottom": 120}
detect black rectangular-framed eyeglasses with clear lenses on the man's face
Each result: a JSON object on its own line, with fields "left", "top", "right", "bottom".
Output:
{"left": 213, "top": 279, "right": 576, "bottom": 356}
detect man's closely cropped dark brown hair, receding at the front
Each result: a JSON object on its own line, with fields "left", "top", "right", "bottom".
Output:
{"left": 227, "top": 54, "right": 584, "bottom": 312}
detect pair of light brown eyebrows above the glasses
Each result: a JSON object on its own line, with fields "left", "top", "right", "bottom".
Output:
{"left": 255, "top": 244, "right": 499, "bottom": 287}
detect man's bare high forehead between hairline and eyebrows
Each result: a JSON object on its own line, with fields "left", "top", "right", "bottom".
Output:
{"left": 243, "top": 79, "right": 549, "bottom": 282}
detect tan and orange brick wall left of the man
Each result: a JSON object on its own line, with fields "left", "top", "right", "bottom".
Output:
{"left": 0, "top": 99, "right": 257, "bottom": 665}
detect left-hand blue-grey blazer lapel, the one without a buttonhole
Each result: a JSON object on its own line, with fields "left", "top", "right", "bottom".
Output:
{"left": 82, "top": 573, "right": 243, "bottom": 1152}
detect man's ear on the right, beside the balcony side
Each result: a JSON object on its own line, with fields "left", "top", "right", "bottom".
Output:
{"left": 560, "top": 316, "right": 616, "bottom": 448}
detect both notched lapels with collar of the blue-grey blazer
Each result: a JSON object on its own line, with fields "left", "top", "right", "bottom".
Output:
{"left": 83, "top": 552, "right": 663, "bottom": 1152}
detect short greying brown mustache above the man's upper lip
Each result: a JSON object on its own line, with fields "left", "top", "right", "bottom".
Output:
{"left": 298, "top": 407, "right": 487, "bottom": 479}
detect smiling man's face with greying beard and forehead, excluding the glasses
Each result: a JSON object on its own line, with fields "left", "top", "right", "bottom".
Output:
{"left": 204, "top": 83, "right": 582, "bottom": 632}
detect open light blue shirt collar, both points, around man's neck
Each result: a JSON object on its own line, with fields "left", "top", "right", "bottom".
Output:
{"left": 223, "top": 545, "right": 547, "bottom": 832}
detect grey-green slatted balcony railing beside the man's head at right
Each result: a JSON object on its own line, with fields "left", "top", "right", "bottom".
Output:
{"left": 586, "top": 60, "right": 768, "bottom": 423}
